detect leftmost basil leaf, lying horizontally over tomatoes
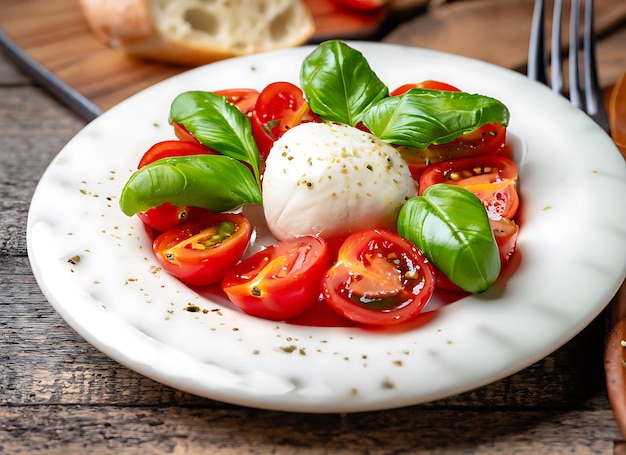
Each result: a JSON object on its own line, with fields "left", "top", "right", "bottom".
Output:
{"left": 120, "top": 155, "right": 262, "bottom": 216}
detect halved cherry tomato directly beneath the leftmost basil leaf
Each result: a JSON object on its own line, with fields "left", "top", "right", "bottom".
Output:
{"left": 152, "top": 212, "right": 252, "bottom": 286}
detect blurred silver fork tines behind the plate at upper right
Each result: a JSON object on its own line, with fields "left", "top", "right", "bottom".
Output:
{"left": 527, "top": 0, "right": 609, "bottom": 133}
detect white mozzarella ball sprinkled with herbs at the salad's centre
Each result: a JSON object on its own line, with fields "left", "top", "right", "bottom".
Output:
{"left": 263, "top": 123, "right": 417, "bottom": 240}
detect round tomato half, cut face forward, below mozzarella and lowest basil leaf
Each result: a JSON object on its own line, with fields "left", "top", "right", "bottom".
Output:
{"left": 322, "top": 229, "right": 435, "bottom": 325}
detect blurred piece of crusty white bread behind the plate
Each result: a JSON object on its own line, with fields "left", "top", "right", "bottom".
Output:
{"left": 80, "top": 0, "right": 315, "bottom": 65}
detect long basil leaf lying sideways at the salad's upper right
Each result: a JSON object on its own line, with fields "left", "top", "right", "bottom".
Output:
{"left": 362, "top": 89, "right": 509, "bottom": 148}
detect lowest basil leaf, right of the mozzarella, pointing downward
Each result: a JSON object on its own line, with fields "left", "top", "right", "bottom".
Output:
{"left": 398, "top": 183, "right": 500, "bottom": 293}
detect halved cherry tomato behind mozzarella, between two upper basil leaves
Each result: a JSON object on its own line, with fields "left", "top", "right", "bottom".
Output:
{"left": 250, "top": 82, "right": 321, "bottom": 159}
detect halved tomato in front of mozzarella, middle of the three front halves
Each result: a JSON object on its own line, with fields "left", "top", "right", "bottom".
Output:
{"left": 222, "top": 235, "right": 329, "bottom": 320}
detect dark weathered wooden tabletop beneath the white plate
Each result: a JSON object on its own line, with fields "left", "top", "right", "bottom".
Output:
{"left": 0, "top": 0, "right": 626, "bottom": 454}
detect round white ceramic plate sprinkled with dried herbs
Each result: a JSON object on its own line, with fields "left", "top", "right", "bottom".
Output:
{"left": 28, "top": 43, "right": 626, "bottom": 412}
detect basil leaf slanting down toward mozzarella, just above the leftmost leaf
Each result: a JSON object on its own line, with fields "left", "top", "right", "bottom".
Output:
{"left": 170, "top": 91, "right": 261, "bottom": 181}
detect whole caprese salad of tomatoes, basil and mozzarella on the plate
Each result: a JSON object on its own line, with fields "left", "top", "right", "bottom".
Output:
{"left": 120, "top": 40, "right": 519, "bottom": 325}
